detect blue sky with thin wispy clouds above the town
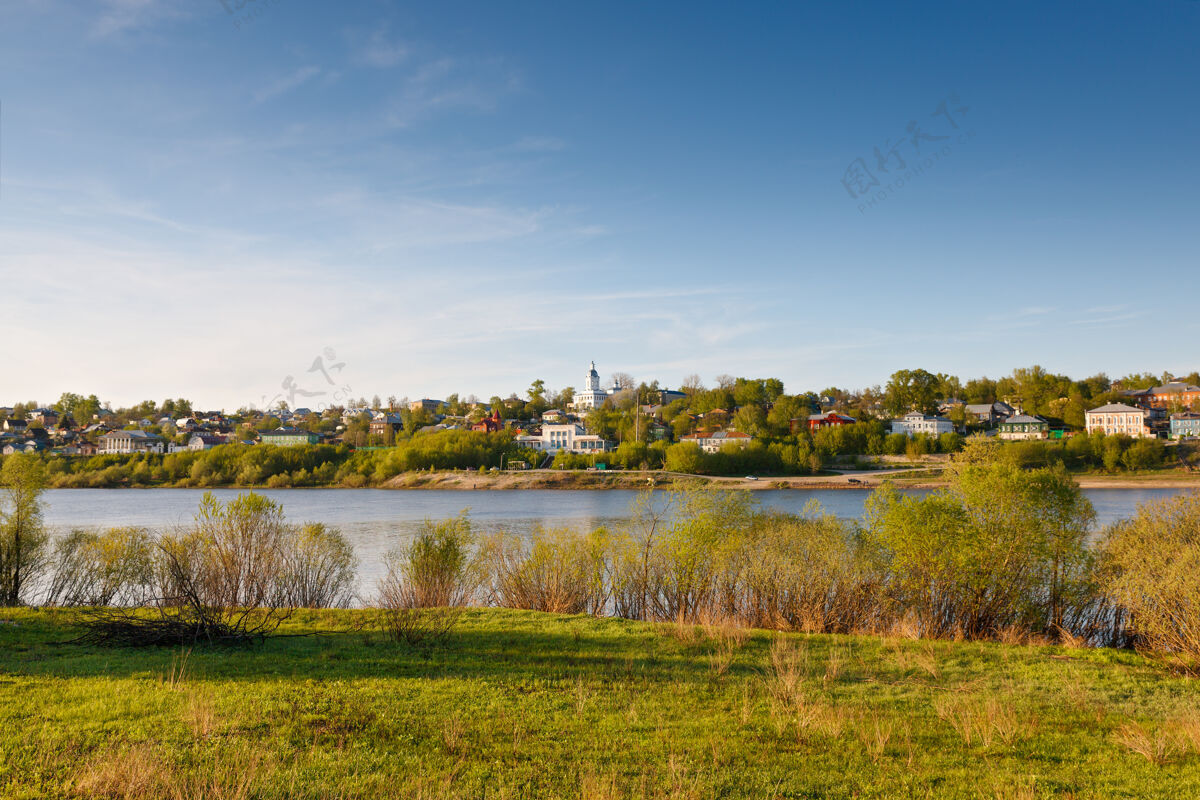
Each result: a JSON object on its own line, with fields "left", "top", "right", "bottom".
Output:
{"left": 0, "top": 0, "right": 1200, "bottom": 409}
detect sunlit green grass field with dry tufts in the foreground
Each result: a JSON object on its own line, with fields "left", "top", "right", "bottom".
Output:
{"left": 0, "top": 609, "right": 1200, "bottom": 799}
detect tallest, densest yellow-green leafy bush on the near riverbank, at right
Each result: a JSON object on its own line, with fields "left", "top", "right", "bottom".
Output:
{"left": 864, "top": 441, "right": 1096, "bottom": 637}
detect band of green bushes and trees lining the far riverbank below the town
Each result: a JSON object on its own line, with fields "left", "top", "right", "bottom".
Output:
{"left": 0, "top": 429, "right": 1171, "bottom": 488}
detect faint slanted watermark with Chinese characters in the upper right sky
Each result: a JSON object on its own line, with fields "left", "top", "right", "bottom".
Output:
{"left": 841, "top": 95, "right": 974, "bottom": 213}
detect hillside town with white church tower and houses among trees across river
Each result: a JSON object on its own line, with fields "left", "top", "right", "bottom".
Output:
{"left": 0, "top": 362, "right": 1200, "bottom": 467}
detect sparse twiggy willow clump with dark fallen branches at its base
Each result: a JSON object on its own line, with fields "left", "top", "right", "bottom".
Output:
{"left": 74, "top": 493, "right": 354, "bottom": 645}
